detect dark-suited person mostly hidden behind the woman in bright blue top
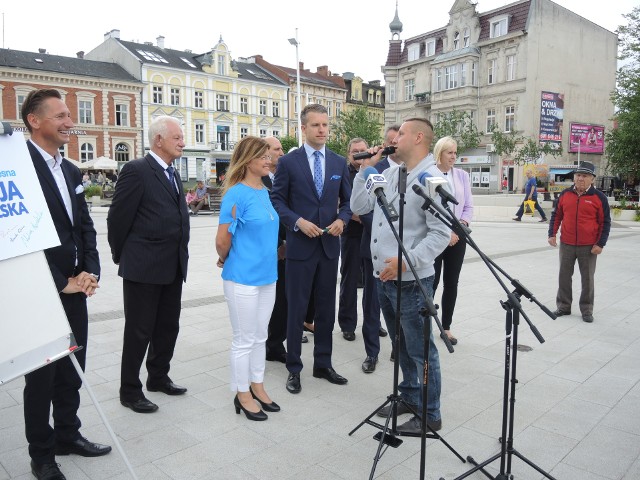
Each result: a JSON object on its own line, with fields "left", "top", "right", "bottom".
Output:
{"left": 262, "top": 137, "right": 287, "bottom": 363}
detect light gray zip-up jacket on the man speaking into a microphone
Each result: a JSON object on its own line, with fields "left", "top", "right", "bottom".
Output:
{"left": 351, "top": 154, "right": 451, "bottom": 281}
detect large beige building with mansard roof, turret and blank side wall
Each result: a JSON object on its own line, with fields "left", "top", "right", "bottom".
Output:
{"left": 383, "top": 0, "right": 618, "bottom": 193}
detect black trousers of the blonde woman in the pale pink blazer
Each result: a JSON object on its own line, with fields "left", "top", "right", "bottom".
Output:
{"left": 433, "top": 240, "right": 467, "bottom": 330}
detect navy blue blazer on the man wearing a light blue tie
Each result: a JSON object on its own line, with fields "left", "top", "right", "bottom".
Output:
{"left": 271, "top": 147, "right": 351, "bottom": 260}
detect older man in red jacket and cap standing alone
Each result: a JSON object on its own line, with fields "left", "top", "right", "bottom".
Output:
{"left": 548, "top": 162, "right": 611, "bottom": 323}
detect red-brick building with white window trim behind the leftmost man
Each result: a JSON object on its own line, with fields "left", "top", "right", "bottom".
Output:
{"left": 0, "top": 49, "right": 144, "bottom": 162}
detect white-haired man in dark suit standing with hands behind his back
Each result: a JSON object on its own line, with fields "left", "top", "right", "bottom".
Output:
{"left": 107, "top": 116, "right": 189, "bottom": 413}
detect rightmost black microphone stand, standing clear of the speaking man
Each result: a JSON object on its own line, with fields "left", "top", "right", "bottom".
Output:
{"left": 416, "top": 192, "right": 556, "bottom": 480}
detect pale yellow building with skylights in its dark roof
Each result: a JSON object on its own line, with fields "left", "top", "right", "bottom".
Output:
{"left": 87, "top": 30, "right": 289, "bottom": 180}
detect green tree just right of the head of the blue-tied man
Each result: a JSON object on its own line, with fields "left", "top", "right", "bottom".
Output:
{"left": 327, "top": 105, "right": 382, "bottom": 156}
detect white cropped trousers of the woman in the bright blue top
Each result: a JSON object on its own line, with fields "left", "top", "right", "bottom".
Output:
{"left": 223, "top": 280, "right": 276, "bottom": 392}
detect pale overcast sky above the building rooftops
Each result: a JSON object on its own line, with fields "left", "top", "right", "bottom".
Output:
{"left": 0, "top": 0, "right": 638, "bottom": 81}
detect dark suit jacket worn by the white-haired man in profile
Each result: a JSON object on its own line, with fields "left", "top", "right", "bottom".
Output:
{"left": 107, "top": 154, "right": 189, "bottom": 285}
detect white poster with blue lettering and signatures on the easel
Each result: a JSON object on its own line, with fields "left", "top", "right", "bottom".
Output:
{"left": 0, "top": 132, "right": 60, "bottom": 260}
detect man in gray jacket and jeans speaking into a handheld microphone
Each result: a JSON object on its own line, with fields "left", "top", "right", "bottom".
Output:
{"left": 351, "top": 118, "right": 451, "bottom": 433}
